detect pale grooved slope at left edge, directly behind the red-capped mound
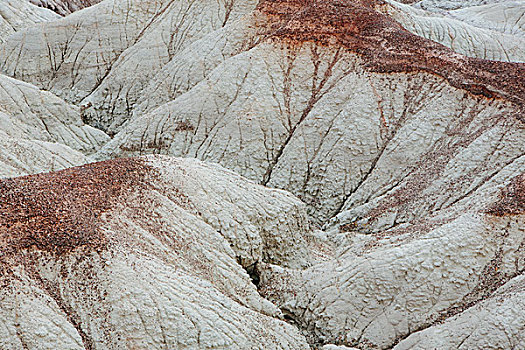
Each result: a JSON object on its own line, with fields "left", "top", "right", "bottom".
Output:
{"left": 0, "top": 75, "right": 109, "bottom": 177}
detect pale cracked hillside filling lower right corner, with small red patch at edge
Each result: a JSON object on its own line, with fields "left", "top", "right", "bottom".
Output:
{"left": 260, "top": 169, "right": 525, "bottom": 349}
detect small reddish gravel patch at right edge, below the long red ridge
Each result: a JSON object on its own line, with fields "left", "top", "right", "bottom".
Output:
{"left": 487, "top": 173, "right": 525, "bottom": 217}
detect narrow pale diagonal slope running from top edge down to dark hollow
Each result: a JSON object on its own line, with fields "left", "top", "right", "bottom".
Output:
{"left": 81, "top": 0, "right": 258, "bottom": 134}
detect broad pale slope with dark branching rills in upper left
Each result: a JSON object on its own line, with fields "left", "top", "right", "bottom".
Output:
{"left": 1, "top": 0, "right": 177, "bottom": 102}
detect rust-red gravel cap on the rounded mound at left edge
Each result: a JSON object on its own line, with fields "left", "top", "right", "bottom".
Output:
{"left": 0, "top": 158, "right": 148, "bottom": 261}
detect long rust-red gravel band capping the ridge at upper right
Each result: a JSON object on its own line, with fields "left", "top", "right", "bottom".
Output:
{"left": 258, "top": 0, "right": 525, "bottom": 121}
